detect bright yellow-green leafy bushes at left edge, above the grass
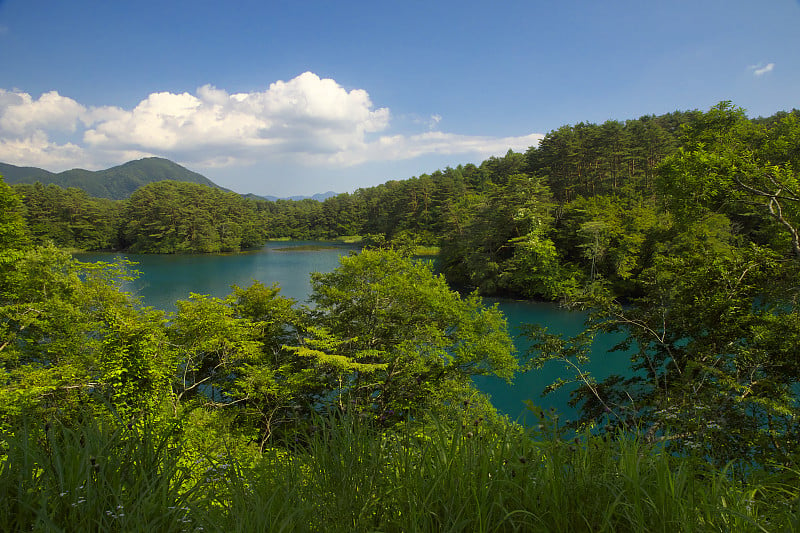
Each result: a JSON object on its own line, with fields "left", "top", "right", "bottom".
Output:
{"left": 0, "top": 243, "right": 170, "bottom": 422}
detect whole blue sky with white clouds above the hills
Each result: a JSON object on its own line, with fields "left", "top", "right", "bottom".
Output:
{"left": 0, "top": 0, "right": 800, "bottom": 196}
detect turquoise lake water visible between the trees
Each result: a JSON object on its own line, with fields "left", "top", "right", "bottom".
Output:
{"left": 75, "top": 241, "right": 628, "bottom": 421}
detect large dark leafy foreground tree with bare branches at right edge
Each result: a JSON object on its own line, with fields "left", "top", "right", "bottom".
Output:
{"left": 531, "top": 102, "right": 800, "bottom": 466}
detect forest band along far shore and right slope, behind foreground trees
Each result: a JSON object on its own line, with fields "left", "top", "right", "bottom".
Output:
{"left": 9, "top": 105, "right": 798, "bottom": 299}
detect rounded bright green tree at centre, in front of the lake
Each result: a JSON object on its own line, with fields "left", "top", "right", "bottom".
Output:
{"left": 291, "top": 250, "right": 518, "bottom": 420}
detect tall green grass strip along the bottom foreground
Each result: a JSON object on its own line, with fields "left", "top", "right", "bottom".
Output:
{"left": 0, "top": 410, "right": 800, "bottom": 532}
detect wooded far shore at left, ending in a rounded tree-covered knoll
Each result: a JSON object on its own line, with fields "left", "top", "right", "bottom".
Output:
{"left": 14, "top": 181, "right": 267, "bottom": 254}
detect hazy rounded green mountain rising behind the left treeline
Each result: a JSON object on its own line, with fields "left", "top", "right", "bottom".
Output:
{"left": 0, "top": 157, "right": 219, "bottom": 200}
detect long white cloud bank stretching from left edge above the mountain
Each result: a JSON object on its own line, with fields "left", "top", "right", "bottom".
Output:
{"left": 0, "top": 72, "right": 542, "bottom": 174}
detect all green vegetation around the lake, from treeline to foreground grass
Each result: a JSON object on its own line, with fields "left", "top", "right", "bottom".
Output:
{"left": 0, "top": 102, "right": 800, "bottom": 531}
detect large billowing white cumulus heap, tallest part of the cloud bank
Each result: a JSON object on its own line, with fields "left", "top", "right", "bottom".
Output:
{"left": 84, "top": 72, "right": 389, "bottom": 164}
